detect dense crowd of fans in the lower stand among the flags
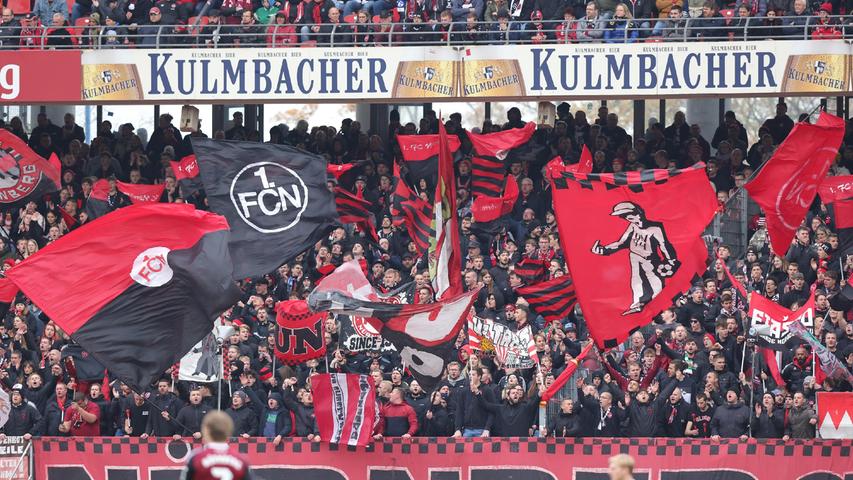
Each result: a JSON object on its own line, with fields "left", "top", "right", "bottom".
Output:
{"left": 0, "top": 103, "right": 853, "bottom": 442}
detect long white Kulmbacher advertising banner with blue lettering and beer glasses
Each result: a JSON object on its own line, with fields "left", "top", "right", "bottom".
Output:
{"left": 75, "top": 40, "right": 851, "bottom": 103}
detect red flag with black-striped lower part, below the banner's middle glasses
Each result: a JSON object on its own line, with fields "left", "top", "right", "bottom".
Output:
{"left": 468, "top": 122, "right": 536, "bottom": 197}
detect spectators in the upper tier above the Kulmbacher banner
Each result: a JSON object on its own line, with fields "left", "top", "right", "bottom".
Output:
{"left": 0, "top": 0, "right": 853, "bottom": 48}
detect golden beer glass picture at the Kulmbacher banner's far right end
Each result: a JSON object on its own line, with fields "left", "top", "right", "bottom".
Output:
{"left": 782, "top": 54, "right": 853, "bottom": 92}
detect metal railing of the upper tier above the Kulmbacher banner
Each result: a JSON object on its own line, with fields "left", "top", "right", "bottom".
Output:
{"left": 0, "top": 15, "right": 853, "bottom": 50}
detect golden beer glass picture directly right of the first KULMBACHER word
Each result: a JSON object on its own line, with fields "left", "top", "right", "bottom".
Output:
{"left": 391, "top": 60, "right": 459, "bottom": 98}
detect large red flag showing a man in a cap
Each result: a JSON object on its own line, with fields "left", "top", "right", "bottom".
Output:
{"left": 551, "top": 163, "right": 717, "bottom": 348}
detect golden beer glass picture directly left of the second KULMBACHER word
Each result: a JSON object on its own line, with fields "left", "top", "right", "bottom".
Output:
{"left": 462, "top": 60, "right": 525, "bottom": 97}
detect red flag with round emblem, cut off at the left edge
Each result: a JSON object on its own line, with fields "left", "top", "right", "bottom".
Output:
{"left": 0, "top": 129, "right": 61, "bottom": 208}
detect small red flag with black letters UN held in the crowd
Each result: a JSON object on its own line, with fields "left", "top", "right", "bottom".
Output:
{"left": 275, "top": 300, "right": 326, "bottom": 365}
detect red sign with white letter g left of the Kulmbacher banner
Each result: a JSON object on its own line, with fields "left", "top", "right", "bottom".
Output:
{"left": 0, "top": 50, "right": 81, "bottom": 104}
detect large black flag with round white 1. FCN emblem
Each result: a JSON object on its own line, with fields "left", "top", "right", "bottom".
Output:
{"left": 192, "top": 138, "right": 338, "bottom": 279}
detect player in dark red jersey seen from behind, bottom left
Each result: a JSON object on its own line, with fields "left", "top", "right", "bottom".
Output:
{"left": 181, "top": 410, "right": 252, "bottom": 480}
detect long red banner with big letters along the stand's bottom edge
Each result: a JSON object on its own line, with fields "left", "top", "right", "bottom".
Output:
{"left": 33, "top": 437, "right": 853, "bottom": 480}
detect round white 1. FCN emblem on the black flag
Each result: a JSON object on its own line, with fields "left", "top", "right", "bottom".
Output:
{"left": 231, "top": 162, "right": 308, "bottom": 233}
